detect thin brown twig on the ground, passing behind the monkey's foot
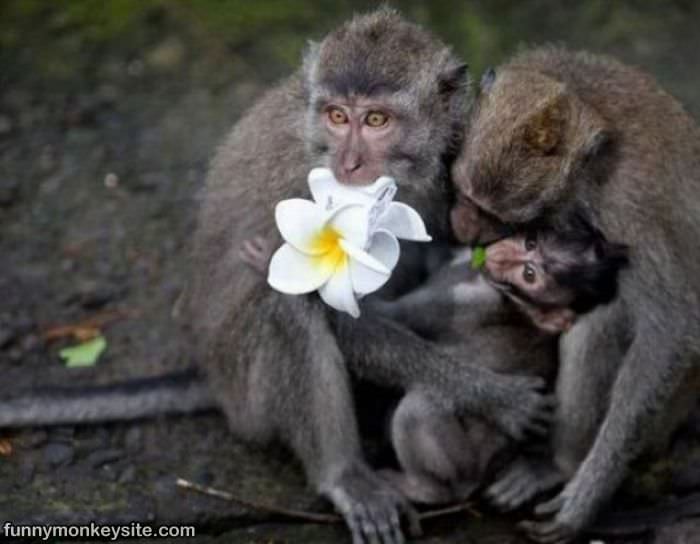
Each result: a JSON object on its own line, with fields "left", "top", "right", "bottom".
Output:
{"left": 176, "top": 478, "right": 481, "bottom": 524}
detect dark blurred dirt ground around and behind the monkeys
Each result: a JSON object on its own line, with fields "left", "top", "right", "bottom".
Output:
{"left": 0, "top": 1, "right": 700, "bottom": 544}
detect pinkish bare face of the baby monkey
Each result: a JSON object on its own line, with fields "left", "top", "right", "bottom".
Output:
{"left": 484, "top": 233, "right": 585, "bottom": 307}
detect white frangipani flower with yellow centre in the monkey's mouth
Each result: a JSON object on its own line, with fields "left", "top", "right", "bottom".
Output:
{"left": 268, "top": 168, "right": 430, "bottom": 317}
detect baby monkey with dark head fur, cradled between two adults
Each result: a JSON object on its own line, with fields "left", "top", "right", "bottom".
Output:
{"left": 241, "top": 223, "right": 627, "bottom": 503}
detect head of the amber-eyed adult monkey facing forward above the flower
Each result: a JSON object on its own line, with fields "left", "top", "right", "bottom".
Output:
{"left": 304, "top": 8, "right": 468, "bottom": 212}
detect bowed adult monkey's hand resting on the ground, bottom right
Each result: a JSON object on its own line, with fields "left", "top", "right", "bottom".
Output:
{"left": 518, "top": 478, "right": 594, "bottom": 544}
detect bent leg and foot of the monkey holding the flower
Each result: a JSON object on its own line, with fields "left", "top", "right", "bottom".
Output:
{"left": 213, "top": 291, "right": 417, "bottom": 544}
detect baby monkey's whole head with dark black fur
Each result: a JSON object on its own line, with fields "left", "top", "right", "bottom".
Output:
{"left": 484, "top": 225, "right": 627, "bottom": 333}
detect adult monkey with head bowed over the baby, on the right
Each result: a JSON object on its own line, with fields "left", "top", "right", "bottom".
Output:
{"left": 450, "top": 47, "right": 700, "bottom": 543}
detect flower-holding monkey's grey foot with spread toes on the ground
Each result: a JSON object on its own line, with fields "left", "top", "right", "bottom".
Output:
{"left": 322, "top": 465, "right": 421, "bottom": 544}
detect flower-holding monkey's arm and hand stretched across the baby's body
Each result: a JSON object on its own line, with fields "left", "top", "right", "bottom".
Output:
{"left": 332, "top": 314, "right": 551, "bottom": 439}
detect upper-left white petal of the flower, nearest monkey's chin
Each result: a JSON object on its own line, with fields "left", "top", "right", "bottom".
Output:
{"left": 275, "top": 198, "right": 325, "bottom": 255}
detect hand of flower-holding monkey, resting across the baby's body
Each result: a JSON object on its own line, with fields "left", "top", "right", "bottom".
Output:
{"left": 482, "top": 376, "right": 556, "bottom": 441}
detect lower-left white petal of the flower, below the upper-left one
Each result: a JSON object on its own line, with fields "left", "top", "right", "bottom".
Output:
{"left": 267, "top": 244, "right": 333, "bottom": 295}
